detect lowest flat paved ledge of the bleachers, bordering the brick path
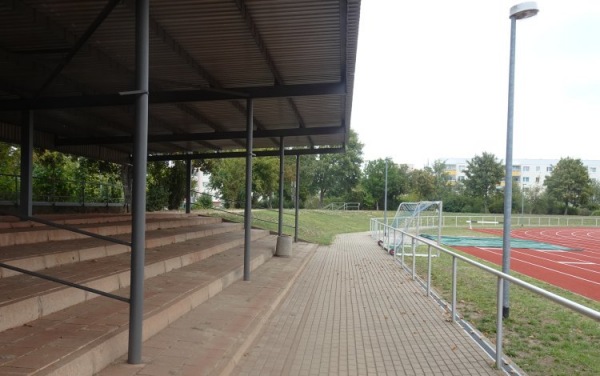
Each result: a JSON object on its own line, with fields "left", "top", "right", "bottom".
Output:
{"left": 96, "top": 243, "right": 317, "bottom": 376}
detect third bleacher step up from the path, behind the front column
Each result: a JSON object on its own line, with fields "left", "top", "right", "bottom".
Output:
{"left": 0, "top": 230, "right": 268, "bottom": 330}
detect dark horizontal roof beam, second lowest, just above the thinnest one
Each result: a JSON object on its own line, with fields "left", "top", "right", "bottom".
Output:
{"left": 56, "top": 126, "right": 346, "bottom": 146}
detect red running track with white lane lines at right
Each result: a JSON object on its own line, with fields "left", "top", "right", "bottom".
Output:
{"left": 455, "top": 227, "right": 600, "bottom": 301}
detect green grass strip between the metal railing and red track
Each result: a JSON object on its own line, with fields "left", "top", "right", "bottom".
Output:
{"left": 405, "top": 228, "right": 600, "bottom": 375}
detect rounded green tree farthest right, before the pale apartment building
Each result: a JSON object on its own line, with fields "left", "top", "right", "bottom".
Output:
{"left": 544, "top": 157, "right": 592, "bottom": 215}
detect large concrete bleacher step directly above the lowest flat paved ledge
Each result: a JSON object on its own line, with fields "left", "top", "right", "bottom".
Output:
{"left": 0, "top": 230, "right": 276, "bottom": 376}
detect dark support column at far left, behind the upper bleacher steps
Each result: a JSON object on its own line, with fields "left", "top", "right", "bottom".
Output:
{"left": 19, "top": 111, "right": 33, "bottom": 218}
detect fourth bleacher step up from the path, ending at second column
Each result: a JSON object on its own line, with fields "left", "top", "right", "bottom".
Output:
{"left": 0, "top": 222, "right": 243, "bottom": 278}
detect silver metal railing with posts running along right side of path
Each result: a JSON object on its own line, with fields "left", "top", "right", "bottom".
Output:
{"left": 371, "top": 218, "right": 600, "bottom": 368}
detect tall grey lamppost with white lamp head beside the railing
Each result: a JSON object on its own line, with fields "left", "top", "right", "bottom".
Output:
{"left": 502, "top": 1, "right": 539, "bottom": 318}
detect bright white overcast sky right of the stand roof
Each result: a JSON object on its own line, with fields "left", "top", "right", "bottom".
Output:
{"left": 351, "top": 0, "right": 600, "bottom": 168}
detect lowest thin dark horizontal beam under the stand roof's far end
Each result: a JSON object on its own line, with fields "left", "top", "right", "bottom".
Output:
{"left": 148, "top": 146, "right": 346, "bottom": 162}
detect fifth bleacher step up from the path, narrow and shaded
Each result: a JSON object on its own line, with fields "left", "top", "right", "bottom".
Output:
{"left": 0, "top": 215, "right": 221, "bottom": 247}
